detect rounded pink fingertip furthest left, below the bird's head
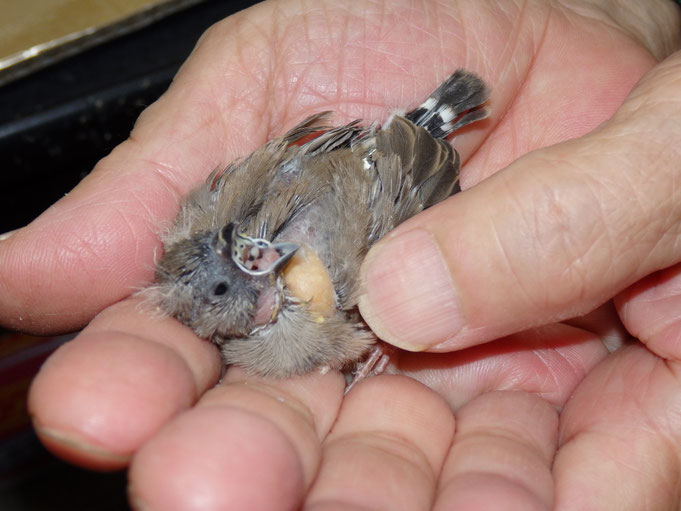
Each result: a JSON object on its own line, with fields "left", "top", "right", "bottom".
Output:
{"left": 28, "top": 332, "right": 198, "bottom": 469}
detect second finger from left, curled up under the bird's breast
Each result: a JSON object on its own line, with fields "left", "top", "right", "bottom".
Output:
{"left": 129, "top": 369, "right": 345, "bottom": 511}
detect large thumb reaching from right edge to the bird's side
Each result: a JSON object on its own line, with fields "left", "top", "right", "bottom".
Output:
{"left": 359, "top": 53, "right": 681, "bottom": 351}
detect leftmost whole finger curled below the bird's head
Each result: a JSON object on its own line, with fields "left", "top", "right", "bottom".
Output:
{"left": 28, "top": 300, "right": 221, "bottom": 469}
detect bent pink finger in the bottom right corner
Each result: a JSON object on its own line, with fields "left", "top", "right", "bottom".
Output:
{"left": 553, "top": 344, "right": 681, "bottom": 511}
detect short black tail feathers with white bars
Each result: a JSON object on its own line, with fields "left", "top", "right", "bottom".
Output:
{"left": 405, "top": 69, "right": 489, "bottom": 138}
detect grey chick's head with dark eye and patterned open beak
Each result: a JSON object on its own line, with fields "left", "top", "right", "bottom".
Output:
{"left": 154, "top": 223, "right": 297, "bottom": 339}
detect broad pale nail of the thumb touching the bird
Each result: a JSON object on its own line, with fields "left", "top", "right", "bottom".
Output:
{"left": 359, "top": 229, "right": 463, "bottom": 351}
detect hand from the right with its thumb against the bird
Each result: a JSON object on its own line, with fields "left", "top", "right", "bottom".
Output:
{"left": 360, "top": 3, "right": 681, "bottom": 509}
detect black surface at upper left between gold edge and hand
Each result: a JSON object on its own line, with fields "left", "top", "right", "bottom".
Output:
{"left": 0, "top": 0, "right": 256, "bottom": 233}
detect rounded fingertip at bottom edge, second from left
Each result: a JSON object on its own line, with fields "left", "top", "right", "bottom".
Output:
{"left": 130, "top": 405, "right": 306, "bottom": 511}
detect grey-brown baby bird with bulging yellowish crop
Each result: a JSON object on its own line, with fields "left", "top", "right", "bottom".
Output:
{"left": 145, "top": 70, "right": 489, "bottom": 377}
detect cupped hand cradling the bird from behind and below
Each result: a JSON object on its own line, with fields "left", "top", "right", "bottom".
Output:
{"left": 5, "top": 2, "right": 673, "bottom": 509}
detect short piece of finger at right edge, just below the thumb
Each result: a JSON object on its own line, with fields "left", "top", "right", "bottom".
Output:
{"left": 616, "top": 264, "right": 681, "bottom": 360}
